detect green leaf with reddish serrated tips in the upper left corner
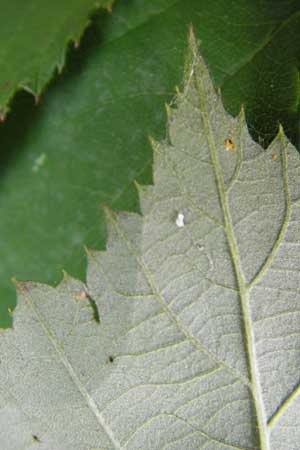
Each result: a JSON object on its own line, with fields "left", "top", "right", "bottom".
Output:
{"left": 0, "top": 0, "right": 112, "bottom": 120}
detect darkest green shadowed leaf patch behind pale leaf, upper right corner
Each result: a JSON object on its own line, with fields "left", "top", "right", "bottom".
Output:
{"left": 221, "top": 0, "right": 300, "bottom": 149}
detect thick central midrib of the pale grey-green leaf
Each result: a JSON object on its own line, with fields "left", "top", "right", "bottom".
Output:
{"left": 193, "top": 59, "right": 270, "bottom": 450}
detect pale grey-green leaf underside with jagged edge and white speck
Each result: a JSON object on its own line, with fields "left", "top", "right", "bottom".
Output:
{"left": 0, "top": 33, "right": 300, "bottom": 450}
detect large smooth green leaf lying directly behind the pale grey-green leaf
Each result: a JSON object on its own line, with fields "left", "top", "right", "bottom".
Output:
{"left": 0, "top": 0, "right": 300, "bottom": 326}
